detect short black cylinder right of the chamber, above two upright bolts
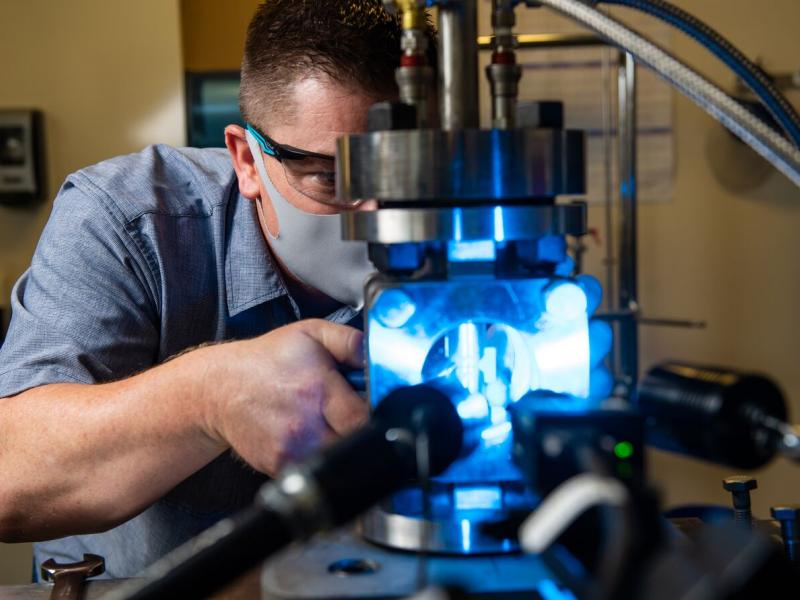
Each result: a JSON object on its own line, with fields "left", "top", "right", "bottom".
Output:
{"left": 638, "top": 362, "right": 786, "bottom": 470}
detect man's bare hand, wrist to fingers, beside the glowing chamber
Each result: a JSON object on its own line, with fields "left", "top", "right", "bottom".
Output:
{"left": 201, "top": 320, "right": 369, "bottom": 475}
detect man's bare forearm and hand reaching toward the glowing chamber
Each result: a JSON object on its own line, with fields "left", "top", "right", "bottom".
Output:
{"left": 0, "top": 320, "right": 367, "bottom": 542}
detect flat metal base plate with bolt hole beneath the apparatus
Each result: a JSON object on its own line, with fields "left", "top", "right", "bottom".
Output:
{"left": 261, "top": 531, "right": 551, "bottom": 600}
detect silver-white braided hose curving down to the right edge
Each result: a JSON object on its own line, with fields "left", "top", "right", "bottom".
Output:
{"left": 539, "top": 0, "right": 800, "bottom": 186}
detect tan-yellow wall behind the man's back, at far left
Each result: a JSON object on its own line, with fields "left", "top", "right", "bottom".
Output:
{"left": 0, "top": 0, "right": 185, "bottom": 584}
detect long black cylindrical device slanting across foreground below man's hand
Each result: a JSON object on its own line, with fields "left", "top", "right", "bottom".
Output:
{"left": 106, "top": 386, "right": 463, "bottom": 600}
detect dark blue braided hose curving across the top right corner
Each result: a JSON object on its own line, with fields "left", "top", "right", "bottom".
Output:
{"left": 600, "top": 0, "right": 800, "bottom": 147}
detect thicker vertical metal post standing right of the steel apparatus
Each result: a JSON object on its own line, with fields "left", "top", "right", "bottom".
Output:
{"left": 617, "top": 52, "right": 639, "bottom": 390}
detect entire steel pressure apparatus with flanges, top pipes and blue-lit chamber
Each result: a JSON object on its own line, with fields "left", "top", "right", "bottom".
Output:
{"left": 337, "top": 0, "right": 589, "bottom": 554}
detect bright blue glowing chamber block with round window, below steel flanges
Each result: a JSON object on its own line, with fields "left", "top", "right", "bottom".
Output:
{"left": 366, "top": 275, "right": 590, "bottom": 490}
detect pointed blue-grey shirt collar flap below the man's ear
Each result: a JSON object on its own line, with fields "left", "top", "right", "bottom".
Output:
{"left": 225, "top": 185, "right": 288, "bottom": 317}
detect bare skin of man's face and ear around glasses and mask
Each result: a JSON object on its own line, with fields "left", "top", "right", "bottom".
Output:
{"left": 225, "top": 76, "right": 381, "bottom": 235}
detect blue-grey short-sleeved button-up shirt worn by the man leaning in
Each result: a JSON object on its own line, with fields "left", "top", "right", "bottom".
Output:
{"left": 0, "top": 146, "right": 357, "bottom": 578}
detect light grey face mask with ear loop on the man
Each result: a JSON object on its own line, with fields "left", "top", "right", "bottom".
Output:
{"left": 246, "top": 131, "right": 375, "bottom": 309}
